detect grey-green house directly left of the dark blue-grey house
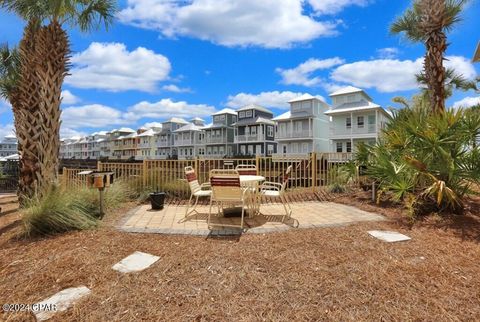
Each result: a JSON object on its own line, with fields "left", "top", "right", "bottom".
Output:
{"left": 203, "top": 108, "right": 237, "bottom": 158}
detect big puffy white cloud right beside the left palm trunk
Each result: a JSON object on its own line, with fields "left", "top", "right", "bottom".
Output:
{"left": 65, "top": 42, "right": 171, "bottom": 92}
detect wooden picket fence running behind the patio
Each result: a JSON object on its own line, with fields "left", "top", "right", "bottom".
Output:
{"left": 62, "top": 153, "right": 358, "bottom": 195}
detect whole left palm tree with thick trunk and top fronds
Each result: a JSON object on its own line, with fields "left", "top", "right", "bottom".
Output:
{"left": 0, "top": 0, "right": 116, "bottom": 201}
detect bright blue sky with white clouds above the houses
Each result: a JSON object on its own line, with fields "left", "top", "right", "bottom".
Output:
{"left": 0, "top": 0, "right": 480, "bottom": 137}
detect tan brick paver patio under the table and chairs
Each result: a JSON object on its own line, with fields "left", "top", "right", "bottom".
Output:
{"left": 119, "top": 202, "right": 385, "bottom": 236}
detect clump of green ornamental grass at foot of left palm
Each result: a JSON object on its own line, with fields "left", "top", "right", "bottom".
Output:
{"left": 22, "top": 189, "right": 98, "bottom": 236}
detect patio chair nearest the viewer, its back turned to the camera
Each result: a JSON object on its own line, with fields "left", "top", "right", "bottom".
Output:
{"left": 208, "top": 169, "right": 249, "bottom": 229}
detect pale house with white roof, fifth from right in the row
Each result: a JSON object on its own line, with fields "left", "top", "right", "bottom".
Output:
{"left": 173, "top": 118, "right": 205, "bottom": 159}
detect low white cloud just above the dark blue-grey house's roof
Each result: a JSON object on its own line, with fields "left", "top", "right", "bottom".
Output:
{"left": 227, "top": 91, "right": 325, "bottom": 109}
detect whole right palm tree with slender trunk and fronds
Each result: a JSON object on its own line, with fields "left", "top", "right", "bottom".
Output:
{"left": 390, "top": 0, "right": 467, "bottom": 113}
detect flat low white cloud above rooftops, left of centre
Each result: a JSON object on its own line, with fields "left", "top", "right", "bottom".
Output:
{"left": 125, "top": 98, "right": 215, "bottom": 120}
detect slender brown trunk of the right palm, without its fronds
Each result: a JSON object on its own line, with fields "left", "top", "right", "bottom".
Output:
{"left": 421, "top": 0, "right": 447, "bottom": 113}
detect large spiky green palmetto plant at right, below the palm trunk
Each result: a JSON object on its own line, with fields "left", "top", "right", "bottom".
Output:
{"left": 359, "top": 97, "right": 480, "bottom": 216}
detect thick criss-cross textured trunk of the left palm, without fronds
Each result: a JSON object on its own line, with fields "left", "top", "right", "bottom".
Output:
{"left": 14, "top": 22, "right": 70, "bottom": 203}
